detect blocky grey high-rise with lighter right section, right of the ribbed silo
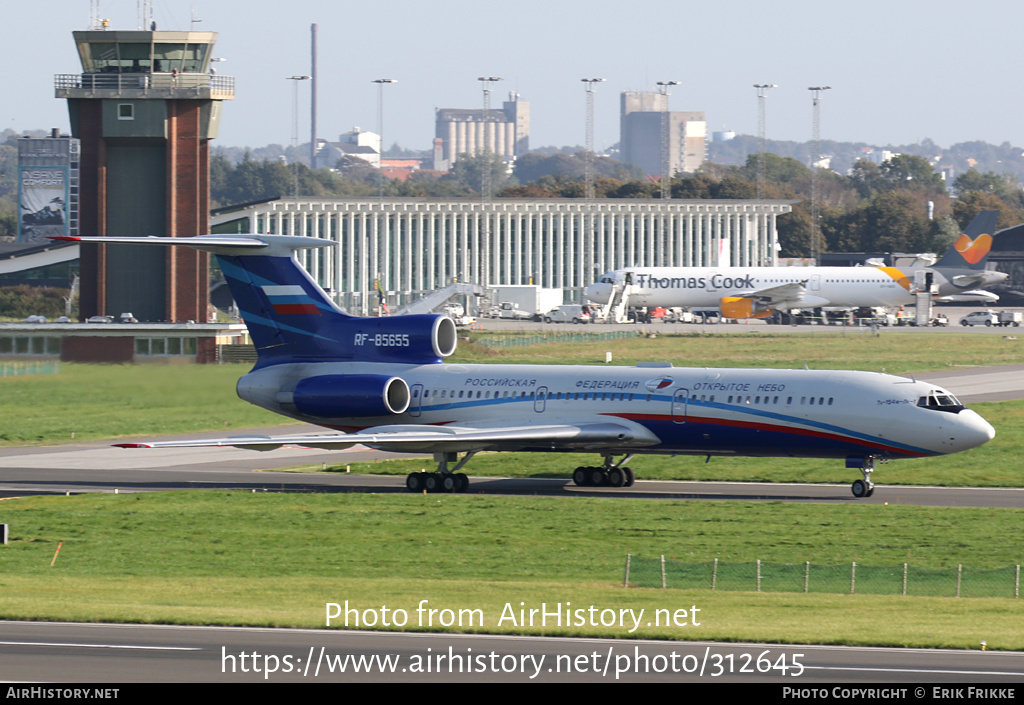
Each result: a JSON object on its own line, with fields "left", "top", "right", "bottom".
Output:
{"left": 620, "top": 91, "right": 708, "bottom": 177}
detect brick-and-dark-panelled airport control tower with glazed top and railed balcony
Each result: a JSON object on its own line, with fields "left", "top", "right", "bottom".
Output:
{"left": 55, "top": 30, "right": 234, "bottom": 323}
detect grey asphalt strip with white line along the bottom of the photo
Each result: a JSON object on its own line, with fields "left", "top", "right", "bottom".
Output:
{"left": 0, "top": 622, "right": 1024, "bottom": 684}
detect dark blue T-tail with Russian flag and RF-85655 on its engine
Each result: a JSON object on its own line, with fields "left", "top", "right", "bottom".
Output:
{"left": 53, "top": 235, "right": 457, "bottom": 367}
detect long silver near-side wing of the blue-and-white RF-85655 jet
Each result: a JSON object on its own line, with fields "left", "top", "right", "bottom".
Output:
{"left": 115, "top": 421, "right": 660, "bottom": 453}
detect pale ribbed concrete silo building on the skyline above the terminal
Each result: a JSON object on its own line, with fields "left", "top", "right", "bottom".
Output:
{"left": 434, "top": 92, "right": 529, "bottom": 171}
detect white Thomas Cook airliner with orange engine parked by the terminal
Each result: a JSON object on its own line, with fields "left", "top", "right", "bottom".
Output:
{"left": 584, "top": 210, "right": 1008, "bottom": 319}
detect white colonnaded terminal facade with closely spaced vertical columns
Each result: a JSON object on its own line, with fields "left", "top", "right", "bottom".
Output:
{"left": 211, "top": 198, "right": 792, "bottom": 313}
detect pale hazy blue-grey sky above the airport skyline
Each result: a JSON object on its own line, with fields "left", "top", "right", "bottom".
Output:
{"left": 8, "top": 0, "right": 1024, "bottom": 150}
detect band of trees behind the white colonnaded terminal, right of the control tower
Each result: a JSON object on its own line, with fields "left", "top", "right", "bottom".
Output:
{"left": 210, "top": 147, "right": 1024, "bottom": 257}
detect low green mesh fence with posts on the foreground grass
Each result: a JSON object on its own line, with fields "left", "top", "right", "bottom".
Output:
{"left": 624, "top": 554, "right": 1021, "bottom": 597}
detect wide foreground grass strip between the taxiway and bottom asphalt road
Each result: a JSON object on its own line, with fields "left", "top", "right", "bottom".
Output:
{"left": 0, "top": 492, "right": 1024, "bottom": 650}
